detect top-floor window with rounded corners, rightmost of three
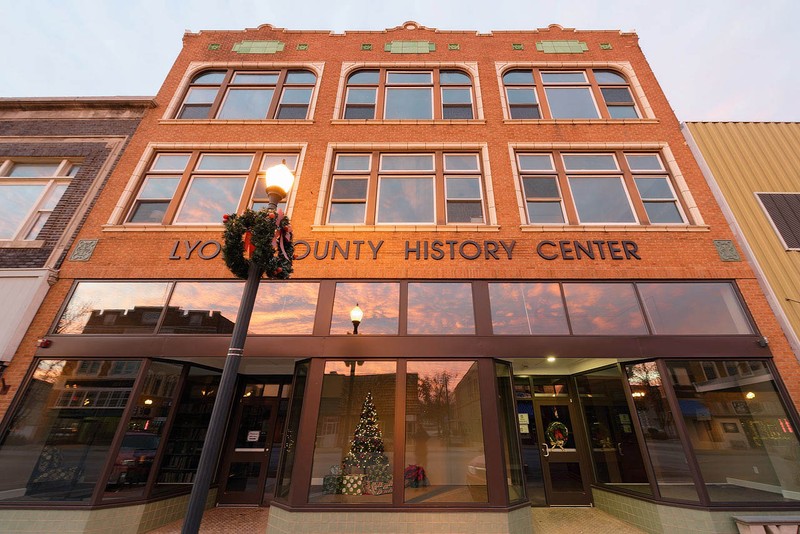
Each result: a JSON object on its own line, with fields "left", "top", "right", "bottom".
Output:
{"left": 503, "top": 68, "right": 640, "bottom": 119}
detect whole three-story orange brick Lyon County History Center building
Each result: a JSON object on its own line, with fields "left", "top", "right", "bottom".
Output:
{"left": 0, "top": 22, "right": 800, "bottom": 532}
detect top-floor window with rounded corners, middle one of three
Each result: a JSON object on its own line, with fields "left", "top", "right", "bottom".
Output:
{"left": 344, "top": 68, "right": 475, "bottom": 120}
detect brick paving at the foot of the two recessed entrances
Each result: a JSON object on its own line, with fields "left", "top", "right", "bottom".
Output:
{"left": 150, "top": 508, "right": 643, "bottom": 534}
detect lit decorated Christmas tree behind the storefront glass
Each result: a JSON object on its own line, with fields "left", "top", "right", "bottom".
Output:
{"left": 342, "top": 392, "right": 390, "bottom": 476}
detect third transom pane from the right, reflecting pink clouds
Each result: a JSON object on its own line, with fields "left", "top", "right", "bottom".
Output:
{"left": 489, "top": 283, "right": 569, "bottom": 335}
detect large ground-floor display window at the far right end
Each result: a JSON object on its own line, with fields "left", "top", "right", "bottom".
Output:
{"left": 667, "top": 361, "right": 800, "bottom": 502}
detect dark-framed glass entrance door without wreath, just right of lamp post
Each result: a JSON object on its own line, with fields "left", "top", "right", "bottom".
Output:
{"left": 217, "top": 392, "right": 278, "bottom": 505}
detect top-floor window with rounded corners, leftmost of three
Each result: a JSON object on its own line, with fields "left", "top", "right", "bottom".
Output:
{"left": 177, "top": 69, "right": 317, "bottom": 120}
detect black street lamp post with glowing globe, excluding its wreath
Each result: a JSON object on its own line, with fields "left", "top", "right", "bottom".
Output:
{"left": 181, "top": 164, "right": 294, "bottom": 534}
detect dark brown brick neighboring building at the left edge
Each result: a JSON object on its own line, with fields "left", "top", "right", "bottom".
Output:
{"left": 0, "top": 97, "right": 153, "bottom": 413}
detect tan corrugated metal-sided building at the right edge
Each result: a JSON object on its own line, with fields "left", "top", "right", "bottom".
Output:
{"left": 683, "top": 122, "right": 800, "bottom": 358}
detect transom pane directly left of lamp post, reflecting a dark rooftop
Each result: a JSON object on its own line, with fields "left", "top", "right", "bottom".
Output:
{"left": 160, "top": 282, "right": 244, "bottom": 334}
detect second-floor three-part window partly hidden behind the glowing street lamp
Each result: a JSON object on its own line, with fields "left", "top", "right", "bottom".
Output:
{"left": 125, "top": 151, "right": 297, "bottom": 224}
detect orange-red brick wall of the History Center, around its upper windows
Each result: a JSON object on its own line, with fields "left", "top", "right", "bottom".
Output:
{"left": 0, "top": 21, "right": 800, "bottom": 409}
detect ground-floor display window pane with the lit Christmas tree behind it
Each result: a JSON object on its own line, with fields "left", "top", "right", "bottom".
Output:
{"left": 308, "top": 360, "right": 397, "bottom": 504}
